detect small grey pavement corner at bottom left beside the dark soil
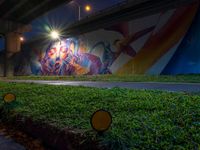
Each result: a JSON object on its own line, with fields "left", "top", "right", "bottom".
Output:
{"left": 0, "top": 133, "right": 25, "bottom": 150}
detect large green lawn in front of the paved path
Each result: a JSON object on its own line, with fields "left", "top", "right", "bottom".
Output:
{"left": 0, "top": 82, "right": 200, "bottom": 150}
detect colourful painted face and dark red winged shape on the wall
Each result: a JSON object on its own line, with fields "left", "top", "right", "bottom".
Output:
{"left": 35, "top": 25, "right": 155, "bottom": 75}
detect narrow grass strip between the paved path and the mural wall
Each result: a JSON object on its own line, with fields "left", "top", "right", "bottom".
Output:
{"left": 0, "top": 75, "right": 200, "bottom": 83}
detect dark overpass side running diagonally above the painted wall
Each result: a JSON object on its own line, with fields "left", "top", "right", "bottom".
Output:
{"left": 63, "top": 0, "right": 197, "bottom": 37}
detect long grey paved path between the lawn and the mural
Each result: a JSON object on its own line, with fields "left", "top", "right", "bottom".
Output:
{"left": 5, "top": 80, "right": 200, "bottom": 92}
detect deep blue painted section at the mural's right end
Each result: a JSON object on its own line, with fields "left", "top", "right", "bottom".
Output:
{"left": 162, "top": 9, "right": 200, "bottom": 74}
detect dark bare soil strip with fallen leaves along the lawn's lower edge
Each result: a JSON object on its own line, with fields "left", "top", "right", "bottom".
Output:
{"left": 0, "top": 113, "right": 103, "bottom": 150}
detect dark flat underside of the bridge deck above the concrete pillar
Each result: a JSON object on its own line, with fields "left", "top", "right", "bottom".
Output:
{"left": 0, "top": 0, "right": 70, "bottom": 24}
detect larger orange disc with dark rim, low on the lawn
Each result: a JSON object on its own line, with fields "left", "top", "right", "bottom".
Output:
{"left": 91, "top": 110, "right": 112, "bottom": 132}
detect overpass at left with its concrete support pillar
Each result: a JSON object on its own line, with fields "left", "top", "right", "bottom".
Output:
{"left": 0, "top": 0, "right": 71, "bottom": 76}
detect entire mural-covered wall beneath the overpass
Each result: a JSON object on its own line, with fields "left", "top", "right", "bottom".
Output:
{"left": 7, "top": 1, "right": 200, "bottom": 75}
